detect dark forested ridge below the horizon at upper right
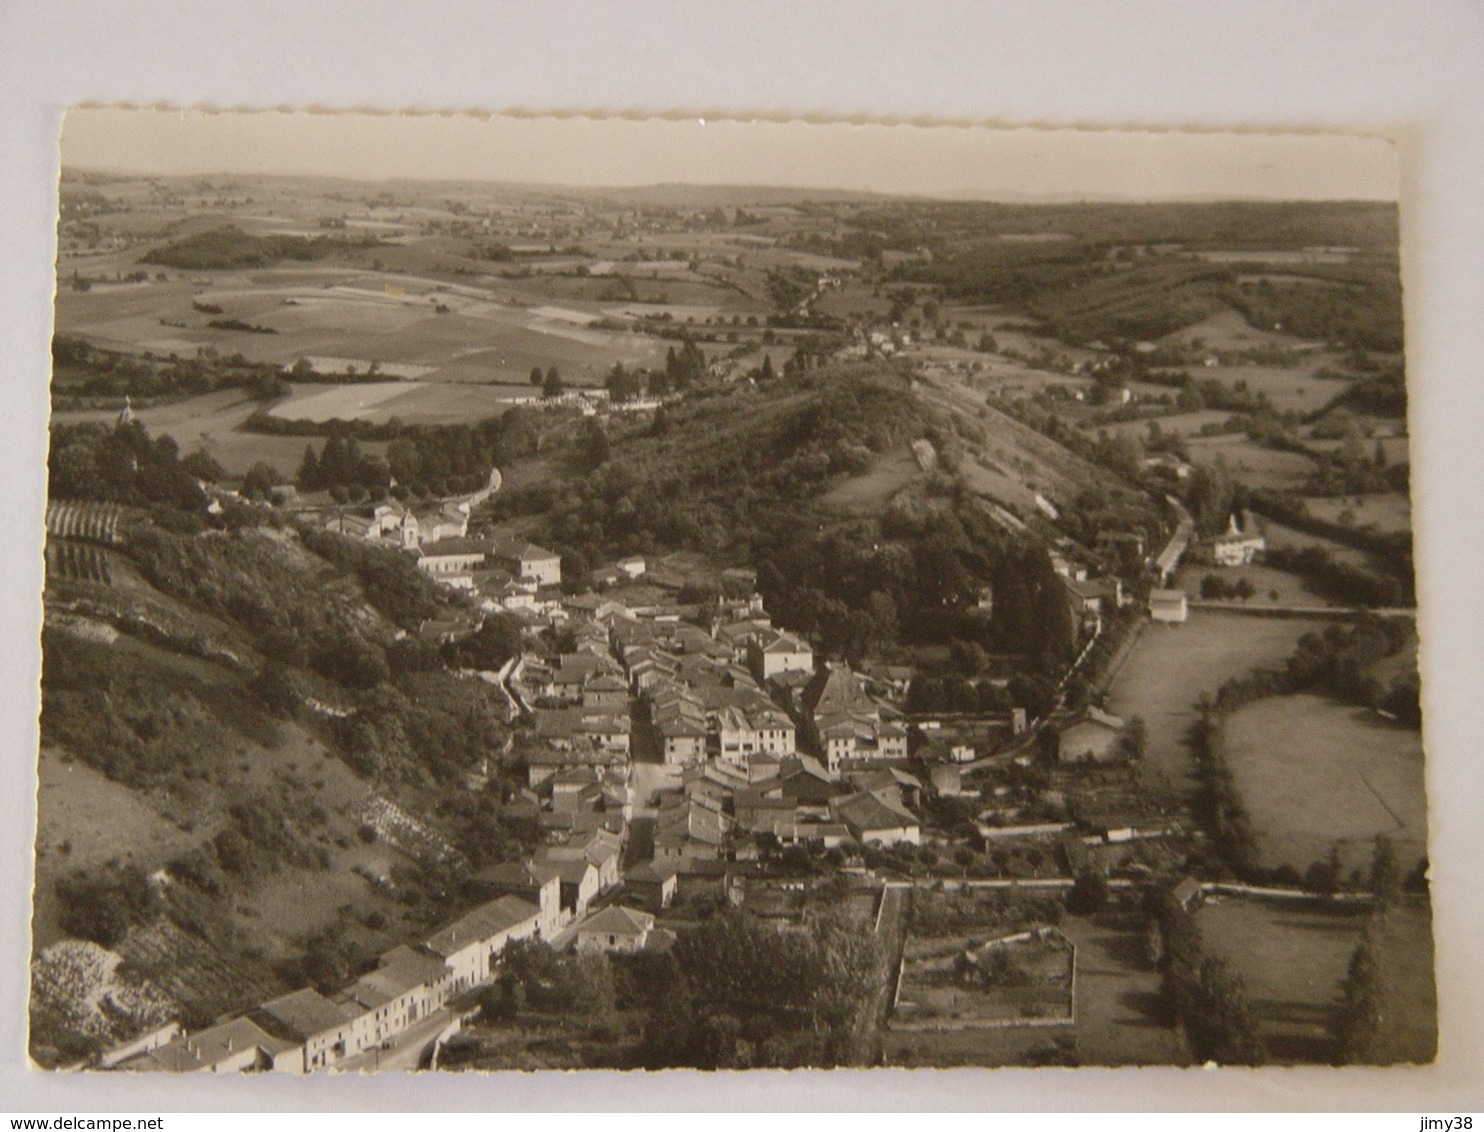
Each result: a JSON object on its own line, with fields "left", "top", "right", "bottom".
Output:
{"left": 878, "top": 197, "right": 1401, "bottom": 350}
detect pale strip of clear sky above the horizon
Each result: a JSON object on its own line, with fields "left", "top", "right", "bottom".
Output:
{"left": 62, "top": 107, "right": 1398, "bottom": 200}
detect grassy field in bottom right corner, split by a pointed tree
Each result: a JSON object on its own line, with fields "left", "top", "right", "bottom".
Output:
{"left": 1196, "top": 898, "right": 1437, "bottom": 1062}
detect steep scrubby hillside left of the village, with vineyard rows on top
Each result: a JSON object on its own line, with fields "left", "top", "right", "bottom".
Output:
{"left": 31, "top": 512, "right": 521, "bottom": 1064}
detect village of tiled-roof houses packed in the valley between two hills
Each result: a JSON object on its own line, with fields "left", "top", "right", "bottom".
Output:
{"left": 86, "top": 456, "right": 1317, "bottom": 1073}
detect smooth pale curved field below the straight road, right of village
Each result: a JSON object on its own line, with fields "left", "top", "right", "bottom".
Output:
{"left": 1109, "top": 610, "right": 1319, "bottom": 800}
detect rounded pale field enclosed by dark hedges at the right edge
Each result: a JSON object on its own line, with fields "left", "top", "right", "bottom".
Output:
{"left": 1224, "top": 696, "right": 1428, "bottom": 872}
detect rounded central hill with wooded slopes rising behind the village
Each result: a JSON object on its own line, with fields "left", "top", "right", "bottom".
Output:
{"left": 496, "top": 362, "right": 1114, "bottom": 672}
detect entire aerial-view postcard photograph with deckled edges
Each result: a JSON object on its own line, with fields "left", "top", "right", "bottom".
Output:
{"left": 28, "top": 105, "right": 1448, "bottom": 1076}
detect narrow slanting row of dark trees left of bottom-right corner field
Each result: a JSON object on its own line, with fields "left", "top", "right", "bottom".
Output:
{"left": 1146, "top": 887, "right": 1267, "bottom": 1065}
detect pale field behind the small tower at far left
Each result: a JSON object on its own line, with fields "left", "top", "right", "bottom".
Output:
{"left": 52, "top": 386, "right": 386, "bottom": 476}
